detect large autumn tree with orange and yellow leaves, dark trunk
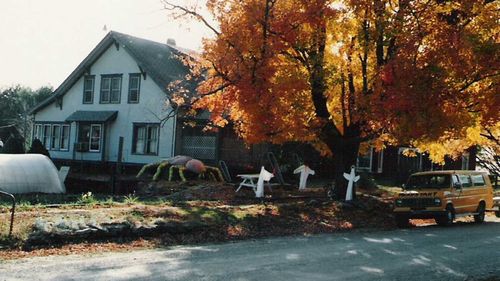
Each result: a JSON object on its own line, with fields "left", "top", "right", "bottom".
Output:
{"left": 164, "top": 0, "right": 500, "bottom": 197}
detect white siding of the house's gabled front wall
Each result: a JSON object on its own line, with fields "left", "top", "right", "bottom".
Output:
{"left": 34, "top": 44, "right": 176, "bottom": 164}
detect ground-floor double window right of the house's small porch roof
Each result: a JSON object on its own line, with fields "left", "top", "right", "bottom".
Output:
{"left": 132, "top": 124, "right": 160, "bottom": 155}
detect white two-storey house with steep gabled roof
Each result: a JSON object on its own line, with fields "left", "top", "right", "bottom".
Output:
{"left": 31, "top": 31, "right": 216, "bottom": 164}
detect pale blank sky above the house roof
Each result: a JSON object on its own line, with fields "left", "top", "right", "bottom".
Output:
{"left": 0, "top": 0, "right": 211, "bottom": 88}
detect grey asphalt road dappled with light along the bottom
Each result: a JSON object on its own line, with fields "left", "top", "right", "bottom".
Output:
{"left": 0, "top": 218, "right": 500, "bottom": 281}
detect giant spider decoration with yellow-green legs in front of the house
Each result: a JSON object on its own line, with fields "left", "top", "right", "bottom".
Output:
{"left": 137, "top": 155, "right": 224, "bottom": 182}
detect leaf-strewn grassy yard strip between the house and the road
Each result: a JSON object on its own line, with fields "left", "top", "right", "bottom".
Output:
{"left": 0, "top": 180, "right": 394, "bottom": 259}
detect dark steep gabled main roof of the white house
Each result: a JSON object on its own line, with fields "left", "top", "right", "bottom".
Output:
{"left": 29, "top": 31, "right": 188, "bottom": 114}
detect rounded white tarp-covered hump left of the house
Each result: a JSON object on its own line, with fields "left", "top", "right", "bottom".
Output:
{"left": 0, "top": 154, "right": 66, "bottom": 194}
